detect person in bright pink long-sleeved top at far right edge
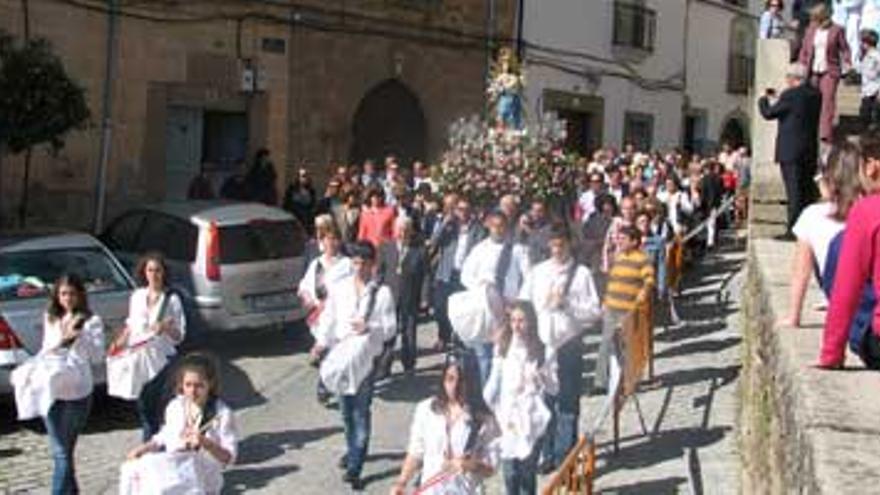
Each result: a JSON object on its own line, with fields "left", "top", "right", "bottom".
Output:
{"left": 819, "top": 136, "right": 880, "bottom": 368}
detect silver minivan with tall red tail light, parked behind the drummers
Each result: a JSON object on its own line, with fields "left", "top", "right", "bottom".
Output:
{"left": 101, "top": 201, "right": 306, "bottom": 330}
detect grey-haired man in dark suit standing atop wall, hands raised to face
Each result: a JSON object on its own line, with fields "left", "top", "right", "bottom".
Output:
{"left": 758, "top": 64, "right": 822, "bottom": 240}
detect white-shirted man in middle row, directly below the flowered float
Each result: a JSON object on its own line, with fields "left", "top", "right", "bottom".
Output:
{"left": 460, "top": 211, "right": 531, "bottom": 384}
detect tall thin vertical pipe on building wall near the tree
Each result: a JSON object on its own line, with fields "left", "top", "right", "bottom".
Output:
{"left": 92, "top": 0, "right": 119, "bottom": 234}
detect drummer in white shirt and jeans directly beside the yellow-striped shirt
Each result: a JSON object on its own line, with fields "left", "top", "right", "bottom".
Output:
{"left": 520, "top": 223, "right": 602, "bottom": 472}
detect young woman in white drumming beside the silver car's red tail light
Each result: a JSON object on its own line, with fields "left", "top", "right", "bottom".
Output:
{"left": 107, "top": 253, "right": 186, "bottom": 441}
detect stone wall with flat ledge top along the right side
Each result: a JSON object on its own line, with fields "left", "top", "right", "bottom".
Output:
{"left": 740, "top": 197, "right": 880, "bottom": 495}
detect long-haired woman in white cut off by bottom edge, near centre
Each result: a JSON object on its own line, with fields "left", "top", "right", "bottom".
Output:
{"left": 391, "top": 356, "right": 500, "bottom": 495}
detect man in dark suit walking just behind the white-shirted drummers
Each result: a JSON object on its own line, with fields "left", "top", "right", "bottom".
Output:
{"left": 378, "top": 216, "right": 428, "bottom": 376}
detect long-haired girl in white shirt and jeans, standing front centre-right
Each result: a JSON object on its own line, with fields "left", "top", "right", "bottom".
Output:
{"left": 483, "top": 301, "right": 558, "bottom": 495}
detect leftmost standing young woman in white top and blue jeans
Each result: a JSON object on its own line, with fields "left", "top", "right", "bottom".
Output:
{"left": 12, "top": 275, "right": 104, "bottom": 494}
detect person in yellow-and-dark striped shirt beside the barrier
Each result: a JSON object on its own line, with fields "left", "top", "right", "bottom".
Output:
{"left": 595, "top": 226, "right": 654, "bottom": 389}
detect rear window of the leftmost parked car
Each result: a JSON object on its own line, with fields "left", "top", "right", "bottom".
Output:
{"left": 0, "top": 248, "right": 131, "bottom": 301}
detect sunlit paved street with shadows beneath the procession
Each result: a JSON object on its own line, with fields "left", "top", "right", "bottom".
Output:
{"left": 0, "top": 235, "right": 744, "bottom": 494}
